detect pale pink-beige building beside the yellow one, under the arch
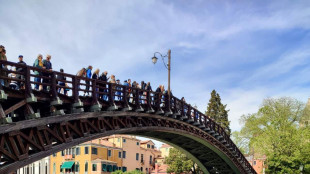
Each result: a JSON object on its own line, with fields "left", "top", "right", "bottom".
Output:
{"left": 103, "top": 135, "right": 161, "bottom": 173}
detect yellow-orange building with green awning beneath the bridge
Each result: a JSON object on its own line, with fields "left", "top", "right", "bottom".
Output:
{"left": 50, "top": 139, "right": 126, "bottom": 174}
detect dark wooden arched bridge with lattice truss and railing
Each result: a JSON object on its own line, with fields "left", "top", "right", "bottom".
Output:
{"left": 0, "top": 61, "right": 256, "bottom": 174}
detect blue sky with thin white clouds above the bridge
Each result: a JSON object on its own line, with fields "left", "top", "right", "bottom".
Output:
{"left": 0, "top": 0, "right": 310, "bottom": 147}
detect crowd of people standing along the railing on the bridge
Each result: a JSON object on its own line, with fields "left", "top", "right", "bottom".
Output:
{"left": 0, "top": 45, "right": 172, "bottom": 103}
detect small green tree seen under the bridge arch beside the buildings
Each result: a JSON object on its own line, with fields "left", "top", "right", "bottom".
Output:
{"left": 165, "top": 148, "right": 202, "bottom": 174}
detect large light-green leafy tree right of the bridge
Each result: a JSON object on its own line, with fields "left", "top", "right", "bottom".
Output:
{"left": 235, "top": 97, "right": 310, "bottom": 173}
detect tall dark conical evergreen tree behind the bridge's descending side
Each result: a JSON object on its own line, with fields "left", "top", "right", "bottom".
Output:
{"left": 206, "top": 90, "right": 231, "bottom": 135}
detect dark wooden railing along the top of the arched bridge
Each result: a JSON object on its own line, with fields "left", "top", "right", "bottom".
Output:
{"left": 0, "top": 61, "right": 251, "bottom": 173}
